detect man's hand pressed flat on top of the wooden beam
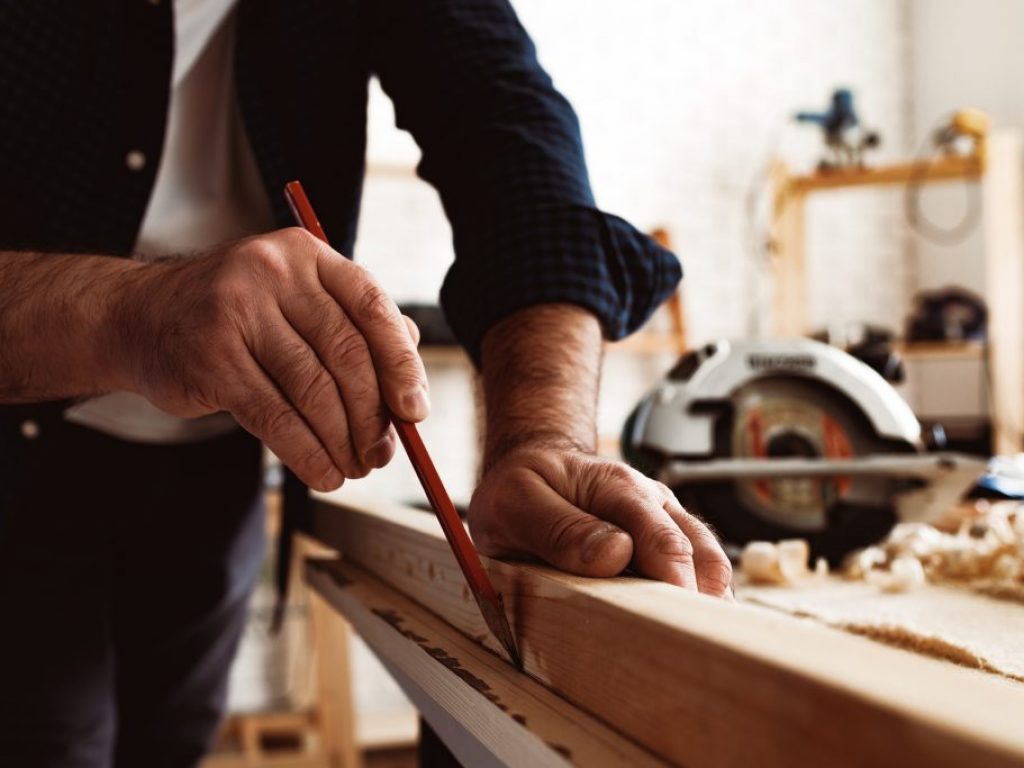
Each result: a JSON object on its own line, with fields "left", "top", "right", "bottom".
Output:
{"left": 469, "top": 447, "right": 732, "bottom": 597}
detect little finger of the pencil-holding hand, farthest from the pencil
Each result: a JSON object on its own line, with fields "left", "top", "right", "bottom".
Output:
{"left": 224, "top": 358, "right": 345, "bottom": 490}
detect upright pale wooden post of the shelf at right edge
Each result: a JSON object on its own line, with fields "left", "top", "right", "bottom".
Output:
{"left": 982, "top": 132, "right": 1024, "bottom": 454}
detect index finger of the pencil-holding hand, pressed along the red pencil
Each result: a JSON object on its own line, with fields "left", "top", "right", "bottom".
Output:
{"left": 317, "top": 250, "right": 430, "bottom": 422}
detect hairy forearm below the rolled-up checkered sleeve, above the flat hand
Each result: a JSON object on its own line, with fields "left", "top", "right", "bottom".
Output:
{"left": 481, "top": 304, "right": 602, "bottom": 471}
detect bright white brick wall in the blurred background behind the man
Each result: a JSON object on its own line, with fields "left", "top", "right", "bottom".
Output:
{"left": 356, "top": 0, "right": 912, "bottom": 505}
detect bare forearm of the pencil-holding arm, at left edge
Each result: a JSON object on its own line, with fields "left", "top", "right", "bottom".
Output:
{"left": 0, "top": 252, "right": 145, "bottom": 402}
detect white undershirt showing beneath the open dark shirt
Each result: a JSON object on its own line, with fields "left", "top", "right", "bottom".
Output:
{"left": 66, "top": 0, "right": 273, "bottom": 443}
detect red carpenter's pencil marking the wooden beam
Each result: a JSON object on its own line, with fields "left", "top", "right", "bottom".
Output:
{"left": 285, "top": 181, "right": 522, "bottom": 670}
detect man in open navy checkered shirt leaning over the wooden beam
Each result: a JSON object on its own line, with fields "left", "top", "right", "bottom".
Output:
{"left": 0, "top": 0, "right": 730, "bottom": 766}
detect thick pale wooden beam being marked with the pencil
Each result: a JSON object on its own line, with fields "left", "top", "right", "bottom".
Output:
{"left": 313, "top": 488, "right": 1024, "bottom": 768}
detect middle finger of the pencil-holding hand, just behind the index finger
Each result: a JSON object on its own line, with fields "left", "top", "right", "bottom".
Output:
{"left": 281, "top": 285, "right": 394, "bottom": 470}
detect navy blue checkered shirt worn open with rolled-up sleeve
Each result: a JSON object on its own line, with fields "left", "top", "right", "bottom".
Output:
{"left": 0, "top": 0, "right": 680, "bottom": 359}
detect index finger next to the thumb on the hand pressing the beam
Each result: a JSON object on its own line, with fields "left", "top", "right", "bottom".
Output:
{"left": 574, "top": 464, "right": 697, "bottom": 591}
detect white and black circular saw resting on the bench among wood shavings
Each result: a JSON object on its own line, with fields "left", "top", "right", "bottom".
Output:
{"left": 623, "top": 339, "right": 985, "bottom": 563}
